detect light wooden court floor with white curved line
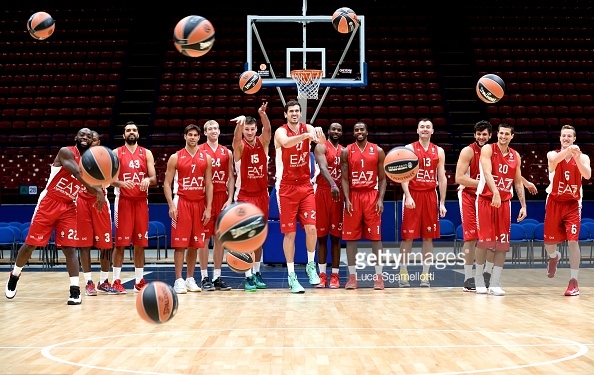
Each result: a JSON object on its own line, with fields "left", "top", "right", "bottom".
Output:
{"left": 0, "top": 268, "right": 594, "bottom": 375}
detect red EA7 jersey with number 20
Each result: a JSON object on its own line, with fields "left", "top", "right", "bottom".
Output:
{"left": 476, "top": 143, "right": 519, "bottom": 202}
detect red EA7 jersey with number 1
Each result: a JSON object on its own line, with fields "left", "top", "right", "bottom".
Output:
{"left": 347, "top": 142, "right": 379, "bottom": 190}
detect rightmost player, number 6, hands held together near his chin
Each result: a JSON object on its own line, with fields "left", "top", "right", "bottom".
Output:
{"left": 544, "top": 125, "right": 592, "bottom": 296}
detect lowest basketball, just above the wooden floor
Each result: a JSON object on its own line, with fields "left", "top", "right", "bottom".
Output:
{"left": 136, "top": 281, "right": 178, "bottom": 324}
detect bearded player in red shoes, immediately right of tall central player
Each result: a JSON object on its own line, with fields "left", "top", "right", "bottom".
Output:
{"left": 314, "top": 122, "right": 344, "bottom": 289}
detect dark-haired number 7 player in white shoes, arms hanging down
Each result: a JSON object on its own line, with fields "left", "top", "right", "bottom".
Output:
{"left": 163, "top": 124, "right": 213, "bottom": 294}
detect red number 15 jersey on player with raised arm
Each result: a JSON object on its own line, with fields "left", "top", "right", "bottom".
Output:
{"left": 235, "top": 137, "right": 268, "bottom": 195}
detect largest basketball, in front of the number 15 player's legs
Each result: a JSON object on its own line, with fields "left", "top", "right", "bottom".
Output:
{"left": 216, "top": 202, "right": 268, "bottom": 253}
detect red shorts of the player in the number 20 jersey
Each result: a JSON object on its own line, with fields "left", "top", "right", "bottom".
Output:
{"left": 476, "top": 197, "right": 511, "bottom": 251}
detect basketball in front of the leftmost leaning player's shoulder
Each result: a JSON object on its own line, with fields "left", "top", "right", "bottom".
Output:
{"left": 79, "top": 146, "right": 120, "bottom": 187}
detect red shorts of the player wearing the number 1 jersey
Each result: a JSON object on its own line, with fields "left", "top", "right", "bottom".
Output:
{"left": 342, "top": 190, "right": 382, "bottom": 241}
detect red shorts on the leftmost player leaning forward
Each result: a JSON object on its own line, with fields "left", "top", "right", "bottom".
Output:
{"left": 25, "top": 190, "right": 77, "bottom": 247}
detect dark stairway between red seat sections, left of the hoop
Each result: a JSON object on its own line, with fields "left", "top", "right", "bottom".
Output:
{"left": 114, "top": 14, "right": 169, "bottom": 139}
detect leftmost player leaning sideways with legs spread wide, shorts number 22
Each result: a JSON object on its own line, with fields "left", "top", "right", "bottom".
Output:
{"left": 4, "top": 128, "right": 105, "bottom": 305}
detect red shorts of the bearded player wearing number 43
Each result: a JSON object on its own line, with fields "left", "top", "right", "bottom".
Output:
{"left": 113, "top": 197, "right": 149, "bottom": 247}
